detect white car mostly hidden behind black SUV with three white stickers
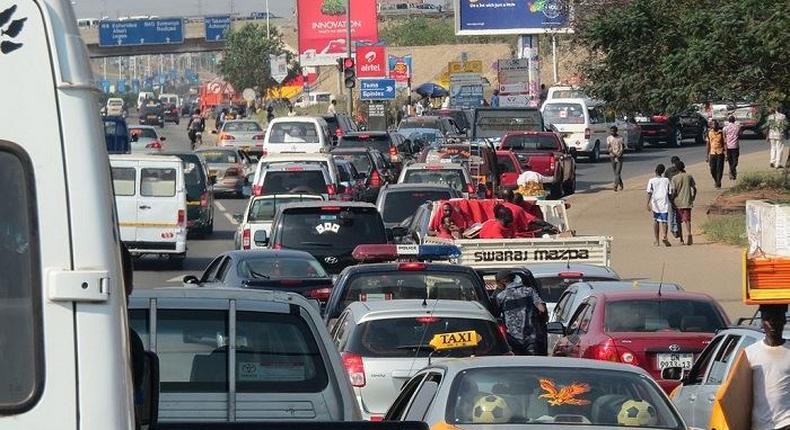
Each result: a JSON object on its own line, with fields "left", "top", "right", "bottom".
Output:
{"left": 235, "top": 194, "right": 323, "bottom": 249}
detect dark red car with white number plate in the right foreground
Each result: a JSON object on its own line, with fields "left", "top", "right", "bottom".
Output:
{"left": 548, "top": 289, "right": 730, "bottom": 393}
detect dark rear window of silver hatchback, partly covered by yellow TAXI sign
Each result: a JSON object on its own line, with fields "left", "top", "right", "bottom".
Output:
{"left": 346, "top": 318, "right": 510, "bottom": 358}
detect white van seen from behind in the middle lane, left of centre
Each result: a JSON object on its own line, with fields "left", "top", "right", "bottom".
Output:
{"left": 263, "top": 116, "right": 332, "bottom": 157}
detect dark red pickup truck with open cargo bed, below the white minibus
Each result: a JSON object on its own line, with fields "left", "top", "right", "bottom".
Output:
{"left": 497, "top": 131, "right": 576, "bottom": 198}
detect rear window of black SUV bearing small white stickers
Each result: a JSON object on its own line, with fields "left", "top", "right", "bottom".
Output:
{"left": 281, "top": 207, "right": 387, "bottom": 251}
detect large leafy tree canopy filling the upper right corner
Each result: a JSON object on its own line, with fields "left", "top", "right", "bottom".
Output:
{"left": 574, "top": 0, "right": 790, "bottom": 112}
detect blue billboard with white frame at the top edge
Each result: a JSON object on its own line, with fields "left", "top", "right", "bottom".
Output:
{"left": 455, "top": 0, "right": 570, "bottom": 35}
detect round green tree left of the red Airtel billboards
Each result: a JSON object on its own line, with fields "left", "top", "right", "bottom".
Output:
{"left": 219, "top": 24, "right": 300, "bottom": 94}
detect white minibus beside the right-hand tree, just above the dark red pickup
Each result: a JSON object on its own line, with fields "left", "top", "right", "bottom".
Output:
{"left": 541, "top": 98, "right": 615, "bottom": 162}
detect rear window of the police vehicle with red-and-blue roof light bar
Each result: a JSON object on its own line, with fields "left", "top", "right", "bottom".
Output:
{"left": 340, "top": 271, "right": 481, "bottom": 309}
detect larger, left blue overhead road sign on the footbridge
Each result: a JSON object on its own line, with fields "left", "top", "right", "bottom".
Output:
{"left": 99, "top": 18, "right": 184, "bottom": 48}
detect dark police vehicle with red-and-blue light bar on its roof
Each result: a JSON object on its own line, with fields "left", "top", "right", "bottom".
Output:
{"left": 324, "top": 245, "right": 494, "bottom": 329}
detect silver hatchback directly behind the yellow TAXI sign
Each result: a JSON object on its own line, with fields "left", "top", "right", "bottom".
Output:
{"left": 332, "top": 300, "right": 511, "bottom": 421}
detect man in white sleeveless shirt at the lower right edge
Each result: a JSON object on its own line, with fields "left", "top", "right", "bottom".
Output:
{"left": 744, "top": 305, "right": 790, "bottom": 430}
